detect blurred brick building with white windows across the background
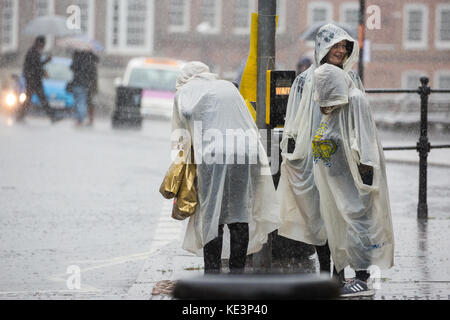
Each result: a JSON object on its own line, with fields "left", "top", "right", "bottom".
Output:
{"left": 0, "top": 0, "right": 450, "bottom": 88}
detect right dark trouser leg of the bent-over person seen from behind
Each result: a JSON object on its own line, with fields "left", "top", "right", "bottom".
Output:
{"left": 228, "top": 223, "right": 249, "bottom": 273}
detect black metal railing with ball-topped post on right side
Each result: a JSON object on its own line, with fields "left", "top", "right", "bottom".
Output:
{"left": 366, "top": 77, "right": 450, "bottom": 219}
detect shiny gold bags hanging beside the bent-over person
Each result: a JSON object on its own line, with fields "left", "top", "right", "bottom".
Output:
{"left": 159, "top": 150, "right": 198, "bottom": 220}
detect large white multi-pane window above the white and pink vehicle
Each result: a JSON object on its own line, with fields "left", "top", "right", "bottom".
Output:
{"left": 106, "top": 0, "right": 154, "bottom": 55}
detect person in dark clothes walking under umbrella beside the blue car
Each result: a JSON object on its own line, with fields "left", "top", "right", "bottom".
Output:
{"left": 16, "top": 36, "right": 58, "bottom": 123}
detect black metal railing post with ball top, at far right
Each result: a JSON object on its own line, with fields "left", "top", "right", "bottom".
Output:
{"left": 417, "top": 77, "right": 431, "bottom": 219}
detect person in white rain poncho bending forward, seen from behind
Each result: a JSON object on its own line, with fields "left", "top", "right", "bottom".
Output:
{"left": 172, "top": 62, "right": 279, "bottom": 273}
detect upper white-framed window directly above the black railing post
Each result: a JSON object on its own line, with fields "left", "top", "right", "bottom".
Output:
{"left": 403, "top": 4, "right": 428, "bottom": 49}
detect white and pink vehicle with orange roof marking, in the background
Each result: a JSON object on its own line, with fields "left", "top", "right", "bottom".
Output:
{"left": 120, "top": 57, "right": 185, "bottom": 118}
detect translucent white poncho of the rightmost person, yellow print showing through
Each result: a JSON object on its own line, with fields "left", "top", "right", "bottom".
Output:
{"left": 312, "top": 64, "right": 394, "bottom": 272}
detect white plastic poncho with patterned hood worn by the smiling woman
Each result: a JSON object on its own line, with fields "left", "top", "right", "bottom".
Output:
{"left": 277, "top": 24, "right": 363, "bottom": 245}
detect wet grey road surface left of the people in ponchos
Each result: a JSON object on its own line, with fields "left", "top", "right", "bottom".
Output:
{"left": 0, "top": 117, "right": 170, "bottom": 299}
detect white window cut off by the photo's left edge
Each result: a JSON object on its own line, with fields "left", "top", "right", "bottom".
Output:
{"left": 0, "top": 0, "right": 19, "bottom": 53}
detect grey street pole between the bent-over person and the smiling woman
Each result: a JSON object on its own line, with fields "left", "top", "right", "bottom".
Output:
{"left": 252, "top": 0, "right": 277, "bottom": 272}
